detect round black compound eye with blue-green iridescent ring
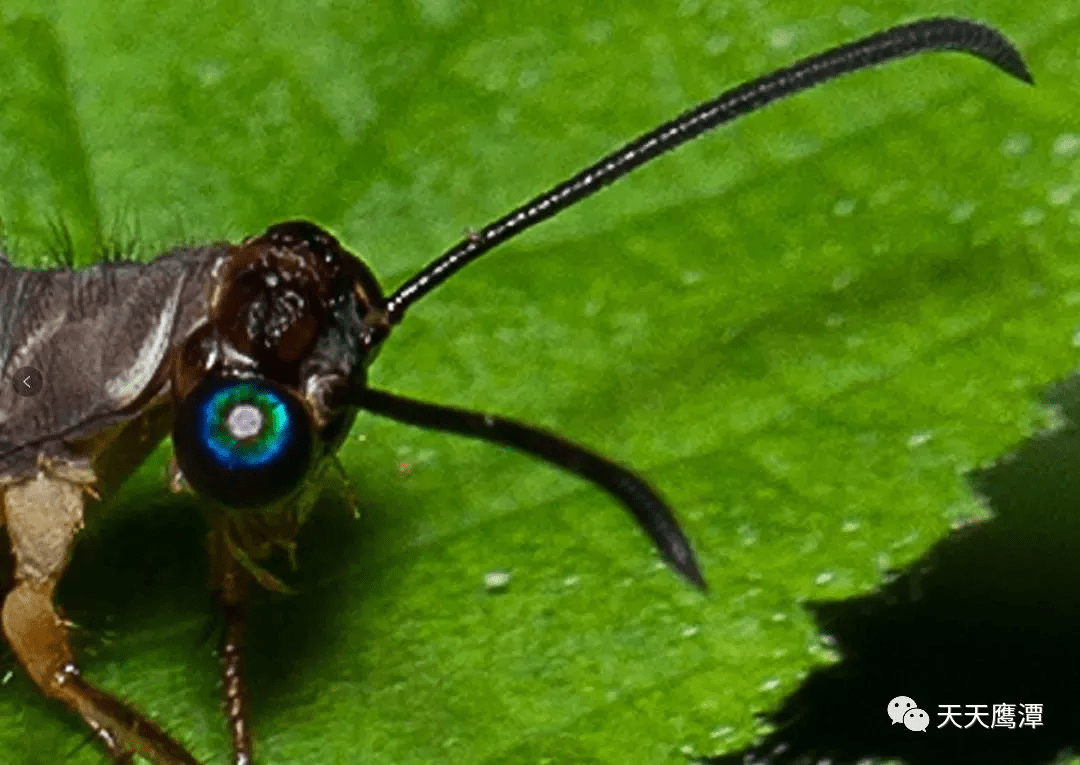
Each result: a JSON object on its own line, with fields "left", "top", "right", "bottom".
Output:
{"left": 173, "top": 377, "right": 314, "bottom": 508}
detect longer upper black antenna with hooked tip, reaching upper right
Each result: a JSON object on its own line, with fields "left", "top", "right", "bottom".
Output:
{"left": 387, "top": 18, "right": 1034, "bottom": 324}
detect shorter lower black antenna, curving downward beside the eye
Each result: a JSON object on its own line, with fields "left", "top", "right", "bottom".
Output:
{"left": 352, "top": 388, "right": 705, "bottom": 590}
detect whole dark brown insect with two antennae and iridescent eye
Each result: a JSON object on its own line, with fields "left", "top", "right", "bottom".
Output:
{"left": 0, "top": 18, "right": 1031, "bottom": 765}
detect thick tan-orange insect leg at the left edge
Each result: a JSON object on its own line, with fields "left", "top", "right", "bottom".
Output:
{"left": 0, "top": 470, "right": 199, "bottom": 765}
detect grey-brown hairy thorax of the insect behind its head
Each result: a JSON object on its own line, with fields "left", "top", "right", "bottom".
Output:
{"left": 0, "top": 244, "right": 228, "bottom": 479}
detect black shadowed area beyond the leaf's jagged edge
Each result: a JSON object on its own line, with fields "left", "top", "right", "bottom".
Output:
{"left": 708, "top": 378, "right": 1080, "bottom": 765}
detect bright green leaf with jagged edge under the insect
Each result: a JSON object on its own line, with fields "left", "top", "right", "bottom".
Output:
{"left": 0, "top": 0, "right": 1080, "bottom": 765}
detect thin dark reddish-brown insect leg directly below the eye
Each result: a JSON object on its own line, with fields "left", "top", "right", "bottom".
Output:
{"left": 210, "top": 519, "right": 253, "bottom": 765}
